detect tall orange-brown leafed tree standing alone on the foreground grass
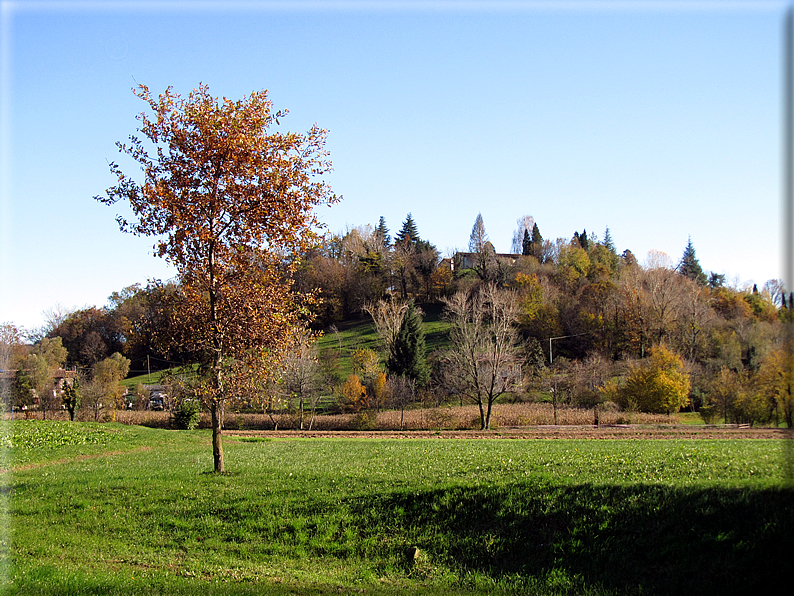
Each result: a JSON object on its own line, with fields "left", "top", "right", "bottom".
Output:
{"left": 96, "top": 85, "right": 337, "bottom": 472}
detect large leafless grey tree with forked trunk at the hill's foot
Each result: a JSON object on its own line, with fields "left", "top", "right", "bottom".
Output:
{"left": 444, "top": 284, "right": 521, "bottom": 430}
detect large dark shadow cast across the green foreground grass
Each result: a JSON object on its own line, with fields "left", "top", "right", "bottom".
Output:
{"left": 347, "top": 484, "right": 794, "bottom": 594}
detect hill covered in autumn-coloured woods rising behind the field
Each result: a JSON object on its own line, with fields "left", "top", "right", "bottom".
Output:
{"left": 3, "top": 214, "right": 792, "bottom": 425}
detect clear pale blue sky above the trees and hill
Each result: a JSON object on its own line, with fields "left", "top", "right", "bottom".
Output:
{"left": 0, "top": 0, "right": 788, "bottom": 328}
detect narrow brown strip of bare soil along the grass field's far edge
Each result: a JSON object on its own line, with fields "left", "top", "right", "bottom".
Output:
{"left": 224, "top": 425, "right": 794, "bottom": 439}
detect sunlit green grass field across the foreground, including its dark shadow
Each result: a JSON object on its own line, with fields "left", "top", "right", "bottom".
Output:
{"left": 0, "top": 421, "right": 794, "bottom": 595}
